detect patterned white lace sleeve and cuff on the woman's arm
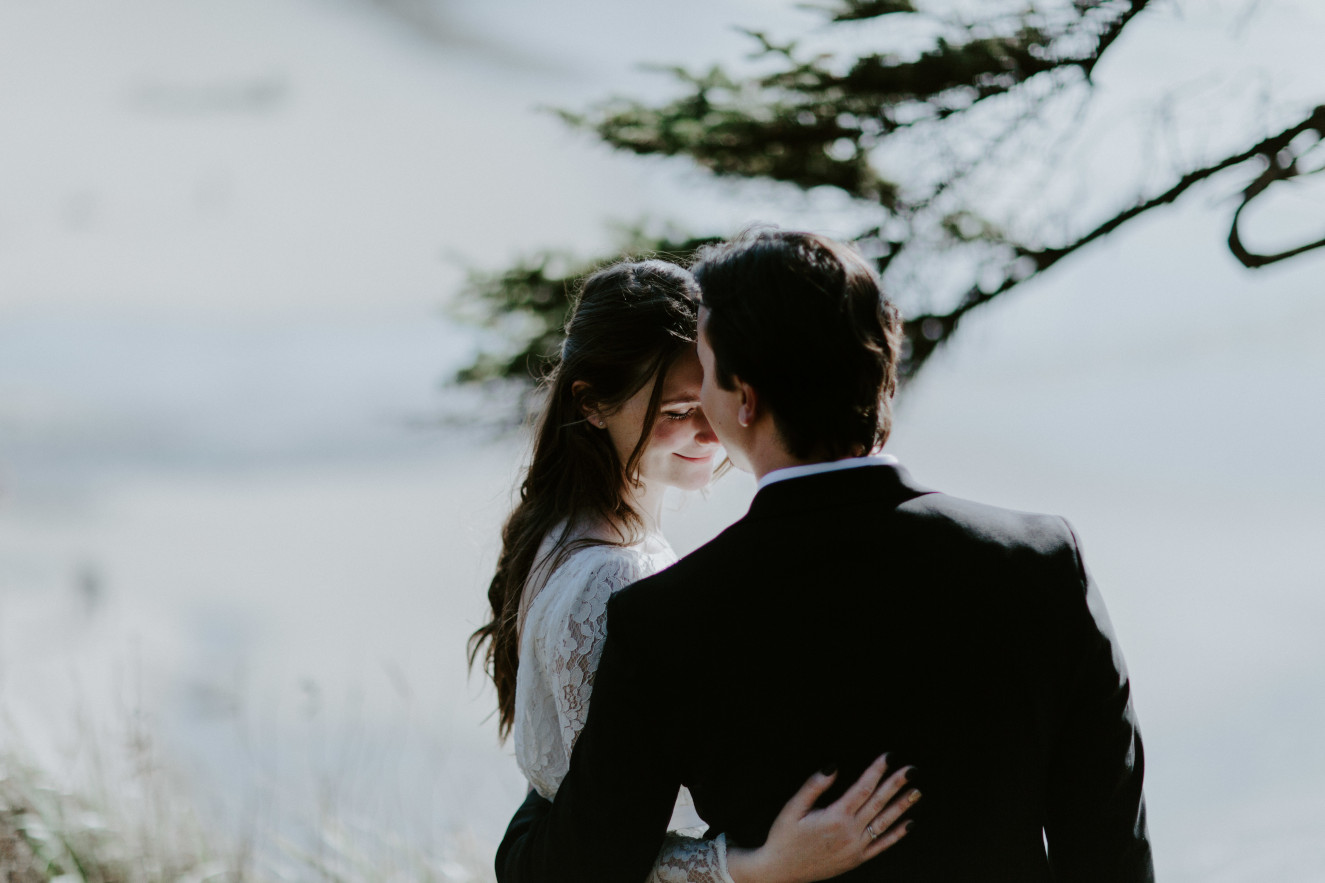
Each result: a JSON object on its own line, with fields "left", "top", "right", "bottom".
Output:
{"left": 532, "top": 550, "right": 733, "bottom": 883}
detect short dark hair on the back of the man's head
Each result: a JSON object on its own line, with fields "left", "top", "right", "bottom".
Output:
{"left": 692, "top": 229, "right": 901, "bottom": 460}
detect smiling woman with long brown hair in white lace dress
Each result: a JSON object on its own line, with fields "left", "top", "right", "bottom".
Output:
{"left": 470, "top": 261, "right": 920, "bottom": 883}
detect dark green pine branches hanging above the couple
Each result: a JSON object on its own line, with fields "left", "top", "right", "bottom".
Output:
{"left": 460, "top": 0, "right": 1325, "bottom": 381}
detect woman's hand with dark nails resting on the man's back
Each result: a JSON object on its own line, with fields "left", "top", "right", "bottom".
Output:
{"left": 727, "top": 754, "right": 920, "bottom": 883}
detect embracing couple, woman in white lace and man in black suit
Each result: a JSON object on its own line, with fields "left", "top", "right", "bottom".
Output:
{"left": 472, "top": 231, "right": 1154, "bottom": 883}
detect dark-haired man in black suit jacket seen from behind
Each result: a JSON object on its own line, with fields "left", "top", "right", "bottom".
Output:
{"left": 497, "top": 231, "right": 1154, "bottom": 883}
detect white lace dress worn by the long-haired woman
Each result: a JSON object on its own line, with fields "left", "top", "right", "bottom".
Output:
{"left": 511, "top": 530, "right": 733, "bottom": 883}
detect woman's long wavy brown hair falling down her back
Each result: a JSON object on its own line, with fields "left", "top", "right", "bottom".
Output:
{"left": 469, "top": 260, "right": 698, "bottom": 740}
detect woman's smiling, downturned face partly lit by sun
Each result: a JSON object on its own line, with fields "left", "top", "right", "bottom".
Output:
{"left": 603, "top": 346, "right": 718, "bottom": 491}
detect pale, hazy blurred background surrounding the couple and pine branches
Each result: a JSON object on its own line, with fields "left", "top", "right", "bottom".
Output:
{"left": 0, "top": 0, "right": 1325, "bottom": 882}
